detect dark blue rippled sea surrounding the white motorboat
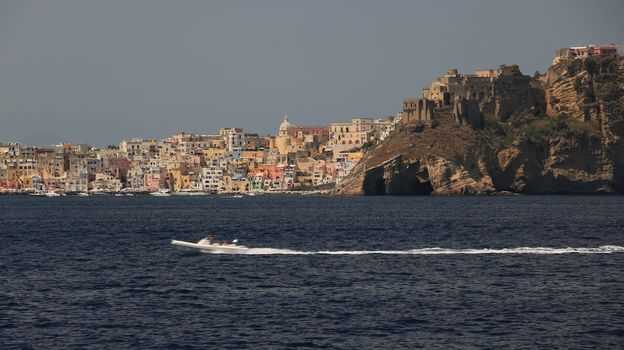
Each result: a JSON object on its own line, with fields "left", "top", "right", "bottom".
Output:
{"left": 0, "top": 196, "right": 624, "bottom": 349}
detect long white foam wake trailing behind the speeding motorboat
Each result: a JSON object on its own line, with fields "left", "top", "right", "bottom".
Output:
{"left": 206, "top": 245, "right": 624, "bottom": 255}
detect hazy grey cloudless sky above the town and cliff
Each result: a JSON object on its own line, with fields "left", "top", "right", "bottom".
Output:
{"left": 0, "top": 0, "right": 624, "bottom": 146}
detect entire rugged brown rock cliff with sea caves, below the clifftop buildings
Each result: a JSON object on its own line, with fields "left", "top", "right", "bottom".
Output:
{"left": 335, "top": 59, "right": 624, "bottom": 195}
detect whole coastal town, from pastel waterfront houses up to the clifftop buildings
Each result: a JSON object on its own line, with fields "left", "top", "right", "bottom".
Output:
{"left": 0, "top": 45, "right": 624, "bottom": 196}
